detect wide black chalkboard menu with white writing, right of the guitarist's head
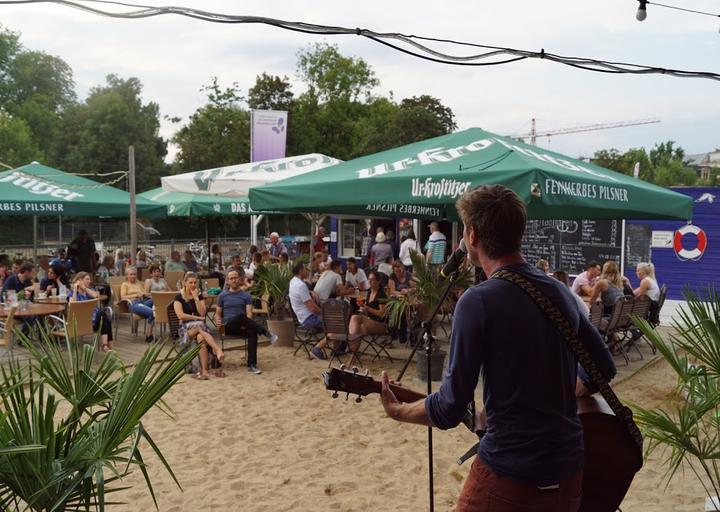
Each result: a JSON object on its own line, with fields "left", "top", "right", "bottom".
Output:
{"left": 522, "top": 220, "right": 622, "bottom": 274}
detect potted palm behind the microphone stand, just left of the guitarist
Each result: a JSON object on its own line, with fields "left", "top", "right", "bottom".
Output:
{"left": 385, "top": 251, "right": 474, "bottom": 380}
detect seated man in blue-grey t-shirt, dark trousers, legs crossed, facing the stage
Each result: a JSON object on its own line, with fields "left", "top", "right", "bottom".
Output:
{"left": 215, "top": 270, "right": 277, "bottom": 375}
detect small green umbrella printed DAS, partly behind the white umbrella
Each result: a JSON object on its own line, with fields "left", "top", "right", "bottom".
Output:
{"left": 138, "top": 188, "right": 255, "bottom": 217}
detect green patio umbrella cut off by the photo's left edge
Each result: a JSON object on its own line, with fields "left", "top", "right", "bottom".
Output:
{"left": 0, "top": 162, "right": 165, "bottom": 218}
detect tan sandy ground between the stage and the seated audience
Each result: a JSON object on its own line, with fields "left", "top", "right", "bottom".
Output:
{"left": 113, "top": 340, "right": 704, "bottom": 512}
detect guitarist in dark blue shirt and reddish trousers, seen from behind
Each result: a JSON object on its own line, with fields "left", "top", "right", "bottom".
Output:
{"left": 382, "top": 185, "right": 615, "bottom": 512}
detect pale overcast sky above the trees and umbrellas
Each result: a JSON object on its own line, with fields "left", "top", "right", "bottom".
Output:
{"left": 0, "top": 0, "right": 720, "bottom": 162}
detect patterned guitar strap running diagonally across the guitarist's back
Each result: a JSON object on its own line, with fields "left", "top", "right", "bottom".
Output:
{"left": 491, "top": 269, "right": 643, "bottom": 463}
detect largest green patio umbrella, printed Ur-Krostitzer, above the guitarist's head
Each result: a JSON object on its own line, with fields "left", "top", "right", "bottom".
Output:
{"left": 250, "top": 128, "right": 693, "bottom": 220}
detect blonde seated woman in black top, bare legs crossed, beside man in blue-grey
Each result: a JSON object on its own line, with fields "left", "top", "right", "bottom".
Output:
{"left": 173, "top": 272, "right": 225, "bottom": 380}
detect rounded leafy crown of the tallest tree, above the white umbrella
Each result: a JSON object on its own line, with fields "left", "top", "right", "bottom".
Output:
{"left": 297, "top": 43, "right": 380, "bottom": 103}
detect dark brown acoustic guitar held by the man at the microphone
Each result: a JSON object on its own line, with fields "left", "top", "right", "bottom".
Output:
{"left": 323, "top": 367, "right": 642, "bottom": 512}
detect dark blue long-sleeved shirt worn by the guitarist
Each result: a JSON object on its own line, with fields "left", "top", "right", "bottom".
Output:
{"left": 425, "top": 263, "right": 615, "bottom": 486}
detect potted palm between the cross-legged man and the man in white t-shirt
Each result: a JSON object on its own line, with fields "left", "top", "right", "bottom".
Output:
{"left": 250, "top": 263, "right": 295, "bottom": 347}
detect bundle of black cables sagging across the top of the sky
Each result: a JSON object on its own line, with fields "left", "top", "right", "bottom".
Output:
{"left": 0, "top": 0, "right": 720, "bottom": 81}
